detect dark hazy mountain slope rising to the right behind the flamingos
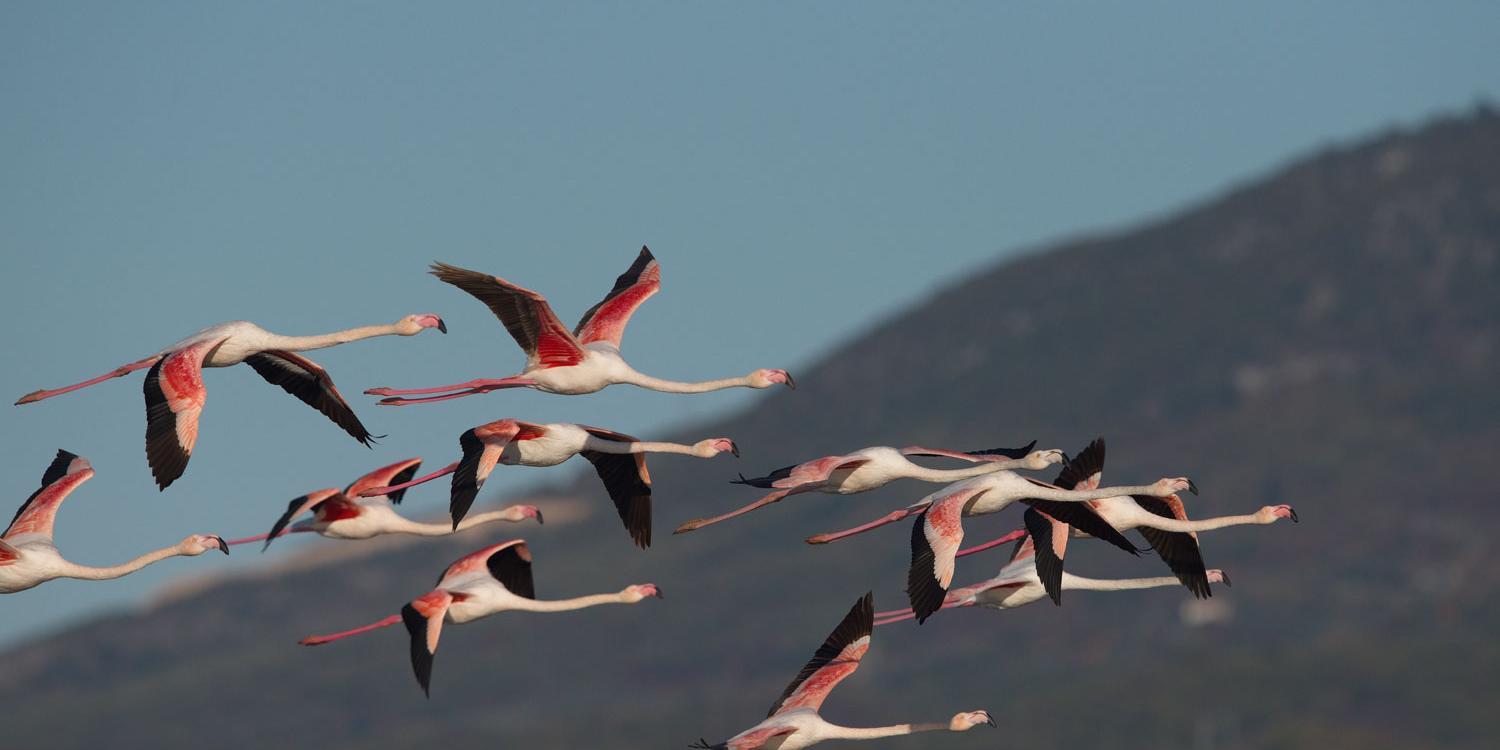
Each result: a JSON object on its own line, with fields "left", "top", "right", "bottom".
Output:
{"left": 0, "top": 108, "right": 1500, "bottom": 750}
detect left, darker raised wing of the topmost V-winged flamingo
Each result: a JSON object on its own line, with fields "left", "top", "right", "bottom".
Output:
{"left": 432, "top": 263, "right": 584, "bottom": 369}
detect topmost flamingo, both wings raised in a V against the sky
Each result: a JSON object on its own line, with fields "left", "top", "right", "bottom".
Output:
{"left": 365, "top": 248, "right": 797, "bottom": 407}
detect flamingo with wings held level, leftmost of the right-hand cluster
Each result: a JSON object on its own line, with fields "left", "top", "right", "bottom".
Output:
{"left": 674, "top": 440, "right": 1064, "bottom": 534}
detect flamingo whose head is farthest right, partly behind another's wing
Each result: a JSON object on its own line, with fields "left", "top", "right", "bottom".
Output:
{"left": 957, "top": 438, "right": 1298, "bottom": 599}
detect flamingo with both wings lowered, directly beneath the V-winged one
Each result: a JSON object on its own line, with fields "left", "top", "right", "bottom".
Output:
{"left": 352, "top": 419, "right": 740, "bottom": 549}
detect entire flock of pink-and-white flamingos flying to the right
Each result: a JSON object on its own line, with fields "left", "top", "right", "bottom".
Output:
{"left": 0, "top": 248, "right": 1298, "bottom": 750}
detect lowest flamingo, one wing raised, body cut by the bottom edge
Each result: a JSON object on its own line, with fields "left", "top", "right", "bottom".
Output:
{"left": 689, "top": 593, "right": 995, "bottom": 750}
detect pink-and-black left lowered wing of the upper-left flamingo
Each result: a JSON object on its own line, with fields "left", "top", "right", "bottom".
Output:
{"left": 141, "top": 339, "right": 225, "bottom": 489}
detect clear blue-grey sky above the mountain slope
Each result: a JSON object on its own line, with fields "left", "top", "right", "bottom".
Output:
{"left": 0, "top": 2, "right": 1500, "bottom": 644}
